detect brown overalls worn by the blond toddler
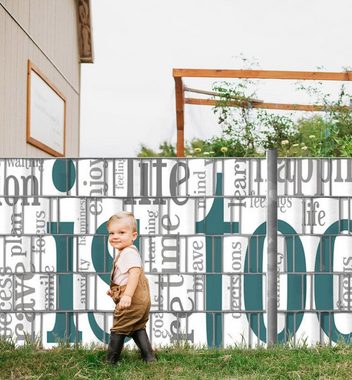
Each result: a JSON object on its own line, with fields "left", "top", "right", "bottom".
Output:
{"left": 110, "top": 249, "right": 150, "bottom": 335}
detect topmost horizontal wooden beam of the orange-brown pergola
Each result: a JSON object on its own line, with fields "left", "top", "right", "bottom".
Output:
{"left": 173, "top": 69, "right": 352, "bottom": 81}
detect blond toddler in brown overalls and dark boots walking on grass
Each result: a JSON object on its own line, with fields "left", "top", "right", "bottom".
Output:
{"left": 107, "top": 211, "right": 155, "bottom": 364}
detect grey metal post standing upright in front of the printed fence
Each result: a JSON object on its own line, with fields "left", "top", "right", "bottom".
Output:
{"left": 266, "top": 149, "right": 278, "bottom": 346}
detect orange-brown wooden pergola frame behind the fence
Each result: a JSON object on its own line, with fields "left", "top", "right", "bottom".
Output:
{"left": 173, "top": 69, "right": 352, "bottom": 157}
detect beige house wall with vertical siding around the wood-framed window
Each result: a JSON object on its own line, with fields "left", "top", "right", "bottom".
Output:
{"left": 0, "top": 0, "right": 80, "bottom": 157}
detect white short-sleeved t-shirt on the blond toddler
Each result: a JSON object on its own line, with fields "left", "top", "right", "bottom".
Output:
{"left": 112, "top": 245, "right": 142, "bottom": 285}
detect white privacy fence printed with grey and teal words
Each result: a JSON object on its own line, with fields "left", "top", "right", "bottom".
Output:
{"left": 0, "top": 158, "right": 352, "bottom": 347}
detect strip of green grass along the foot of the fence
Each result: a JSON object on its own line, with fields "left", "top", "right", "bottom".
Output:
{"left": 0, "top": 341, "right": 352, "bottom": 380}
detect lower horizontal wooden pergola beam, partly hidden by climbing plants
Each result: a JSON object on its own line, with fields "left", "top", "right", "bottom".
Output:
{"left": 185, "top": 98, "right": 351, "bottom": 111}
